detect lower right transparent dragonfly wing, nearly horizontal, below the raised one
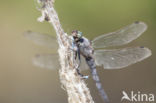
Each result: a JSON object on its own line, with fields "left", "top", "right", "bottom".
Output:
{"left": 94, "top": 47, "right": 151, "bottom": 69}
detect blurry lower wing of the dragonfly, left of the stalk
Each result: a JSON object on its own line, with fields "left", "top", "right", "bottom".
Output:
{"left": 33, "top": 54, "right": 60, "bottom": 70}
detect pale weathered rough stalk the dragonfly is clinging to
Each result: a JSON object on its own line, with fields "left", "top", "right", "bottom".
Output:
{"left": 38, "top": 0, "right": 94, "bottom": 103}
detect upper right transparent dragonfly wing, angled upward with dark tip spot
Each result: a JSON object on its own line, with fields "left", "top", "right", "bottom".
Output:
{"left": 92, "top": 22, "right": 147, "bottom": 48}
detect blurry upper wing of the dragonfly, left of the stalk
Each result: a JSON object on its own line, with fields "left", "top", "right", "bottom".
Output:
{"left": 24, "top": 31, "right": 58, "bottom": 49}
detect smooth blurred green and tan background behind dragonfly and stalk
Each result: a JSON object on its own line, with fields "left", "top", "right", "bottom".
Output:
{"left": 0, "top": 0, "right": 156, "bottom": 103}
